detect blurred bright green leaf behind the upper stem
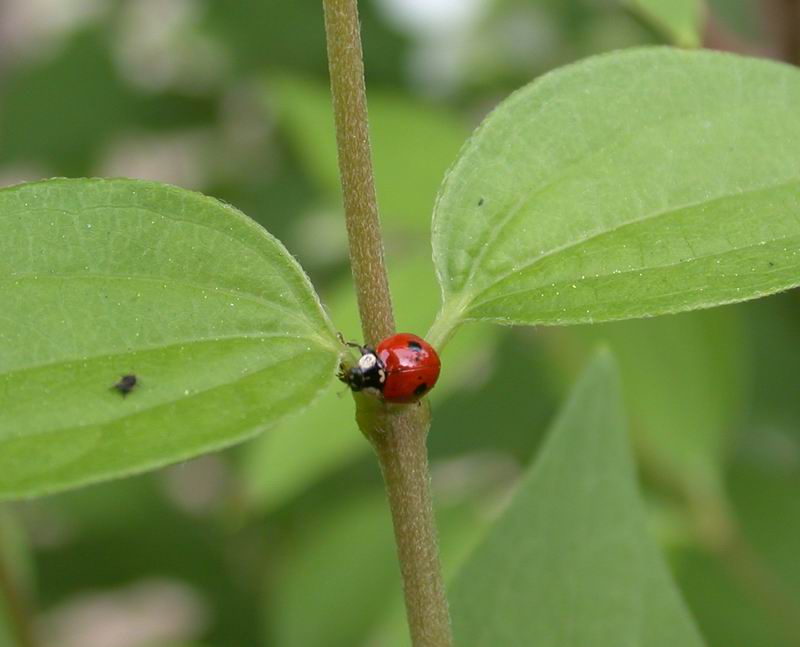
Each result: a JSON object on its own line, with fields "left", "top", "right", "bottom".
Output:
{"left": 267, "top": 76, "right": 469, "bottom": 236}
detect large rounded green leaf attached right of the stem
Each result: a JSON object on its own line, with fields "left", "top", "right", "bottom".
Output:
{"left": 433, "top": 48, "right": 800, "bottom": 339}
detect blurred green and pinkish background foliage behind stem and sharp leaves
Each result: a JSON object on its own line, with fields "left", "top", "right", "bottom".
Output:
{"left": 0, "top": 0, "right": 800, "bottom": 647}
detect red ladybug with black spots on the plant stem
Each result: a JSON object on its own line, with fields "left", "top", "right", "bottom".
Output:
{"left": 339, "top": 333, "right": 441, "bottom": 403}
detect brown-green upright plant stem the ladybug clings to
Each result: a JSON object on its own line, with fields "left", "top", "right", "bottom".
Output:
{"left": 323, "top": 0, "right": 452, "bottom": 647}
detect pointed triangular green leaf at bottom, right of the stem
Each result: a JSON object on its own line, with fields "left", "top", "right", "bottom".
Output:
{"left": 451, "top": 355, "right": 702, "bottom": 647}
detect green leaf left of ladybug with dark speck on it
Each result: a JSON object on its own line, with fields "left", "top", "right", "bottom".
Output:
{"left": 0, "top": 180, "right": 338, "bottom": 497}
